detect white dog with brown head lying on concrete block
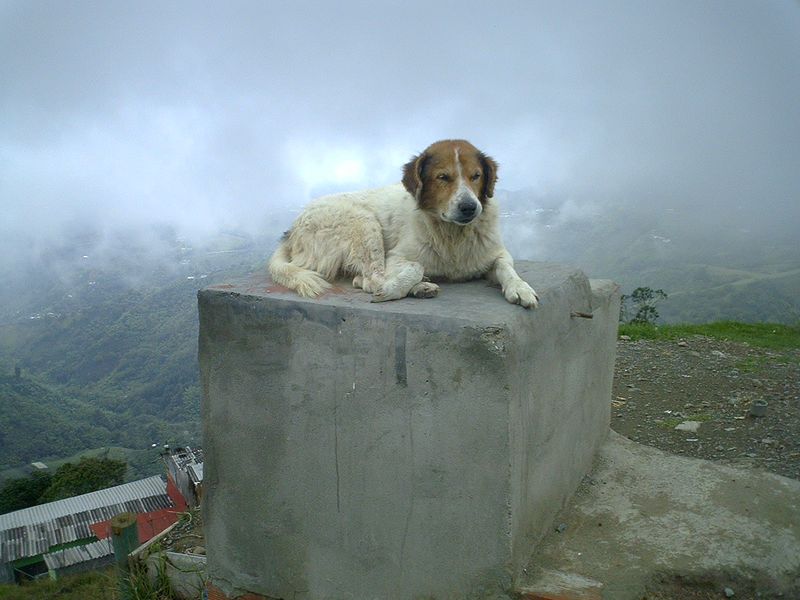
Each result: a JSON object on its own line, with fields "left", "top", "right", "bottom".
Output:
{"left": 268, "top": 140, "right": 539, "bottom": 308}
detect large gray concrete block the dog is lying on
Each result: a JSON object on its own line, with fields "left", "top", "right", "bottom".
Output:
{"left": 199, "top": 262, "right": 619, "bottom": 600}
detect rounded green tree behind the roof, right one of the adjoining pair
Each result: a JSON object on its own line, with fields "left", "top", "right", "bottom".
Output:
{"left": 40, "top": 458, "right": 128, "bottom": 502}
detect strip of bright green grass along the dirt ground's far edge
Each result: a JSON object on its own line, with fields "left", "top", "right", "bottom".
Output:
{"left": 619, "top": 321, "right": 800, "bottom": 351}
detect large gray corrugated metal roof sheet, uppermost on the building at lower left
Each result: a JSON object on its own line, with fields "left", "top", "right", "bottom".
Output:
{"left": 0, "top": 475, "right": 172, "bottom": 563}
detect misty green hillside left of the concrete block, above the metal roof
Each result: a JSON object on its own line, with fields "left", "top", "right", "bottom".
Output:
{"left": 0, "top": 227, "right": 265, "bottom": 476}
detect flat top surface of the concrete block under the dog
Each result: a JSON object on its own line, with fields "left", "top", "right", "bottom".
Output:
{"left": 200, "top": 261, "right": 615, "bottom": 325}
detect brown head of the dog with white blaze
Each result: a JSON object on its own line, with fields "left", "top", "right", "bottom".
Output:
{"left": 403, "top": 140, "right": 497, "bottom": 225}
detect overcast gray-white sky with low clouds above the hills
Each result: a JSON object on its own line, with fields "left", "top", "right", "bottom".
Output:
{"left": 0, "top": 0, "right": 800, "bottom": 246}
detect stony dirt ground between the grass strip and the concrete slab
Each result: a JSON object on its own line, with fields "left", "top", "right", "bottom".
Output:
{"left": 611, "top": 336, "right": 800, "bottom": 479}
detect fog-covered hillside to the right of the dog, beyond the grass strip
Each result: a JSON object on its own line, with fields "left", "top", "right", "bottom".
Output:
{"left": 512, "top": 198, "right": 800, "bottom": 324}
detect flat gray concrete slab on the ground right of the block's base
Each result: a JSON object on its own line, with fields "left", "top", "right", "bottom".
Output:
{"left": 520, "top": 432, "right": 800, "bottom": 600}
